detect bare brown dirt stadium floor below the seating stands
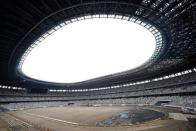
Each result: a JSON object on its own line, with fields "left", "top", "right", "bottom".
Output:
{"left": 0, "top": 106, "right": 195, "bottom": 131}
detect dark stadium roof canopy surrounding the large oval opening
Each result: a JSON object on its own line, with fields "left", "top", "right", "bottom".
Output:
{"left": 0, "top": 0, "right": 196, "bottom": 89}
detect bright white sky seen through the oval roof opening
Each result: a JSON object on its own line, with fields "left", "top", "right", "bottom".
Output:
{"left": 22, "top": 18, "right": 156, "bottom": 83}
